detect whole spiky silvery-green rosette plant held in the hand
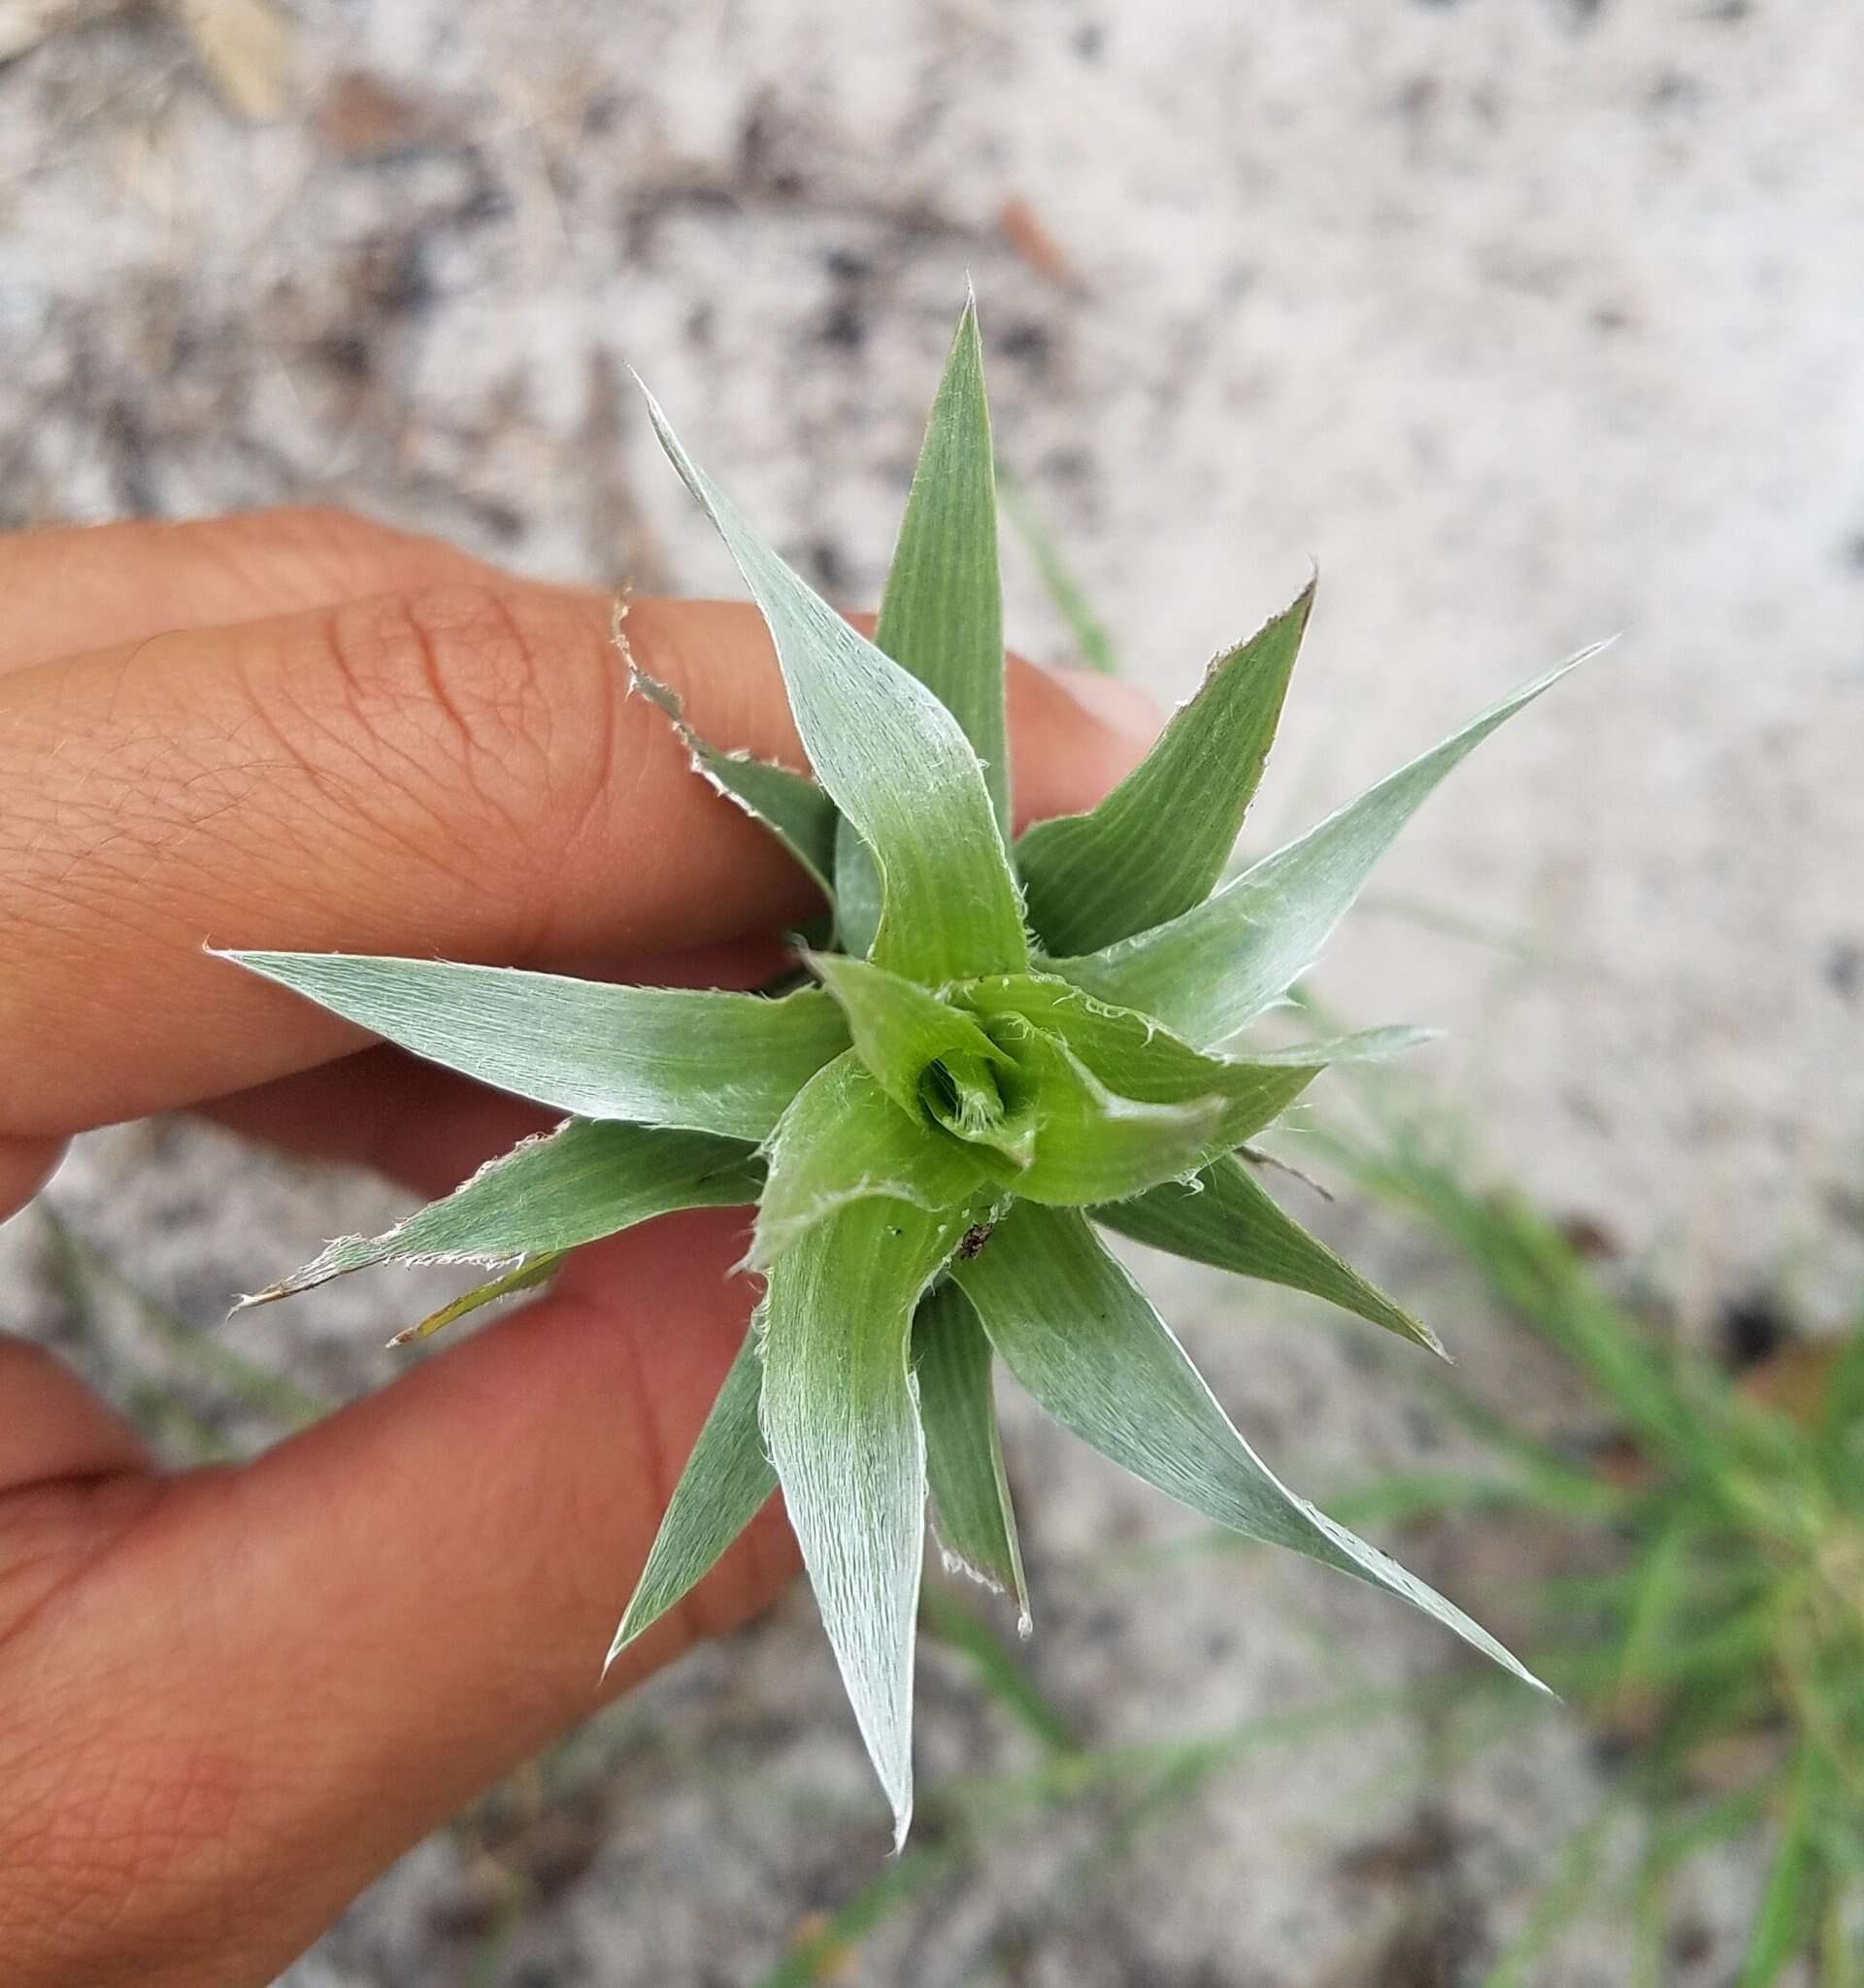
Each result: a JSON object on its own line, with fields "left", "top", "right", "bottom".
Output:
{"left": 232, "top": 306, "right": 1560, "bottom": 1837}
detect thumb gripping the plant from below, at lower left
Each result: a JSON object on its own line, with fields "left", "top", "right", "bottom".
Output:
{"left": 0, "top": 1214, "right": 793, "bottom": 1988}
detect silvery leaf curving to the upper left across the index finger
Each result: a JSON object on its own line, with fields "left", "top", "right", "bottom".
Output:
{"left": 648, "top": 381, "right": 1029, "bottom": 986}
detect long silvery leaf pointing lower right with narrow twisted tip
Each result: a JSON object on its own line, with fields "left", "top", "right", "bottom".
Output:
{"left": 951, "top": 1203, "right": 1544, "bottom": 1690}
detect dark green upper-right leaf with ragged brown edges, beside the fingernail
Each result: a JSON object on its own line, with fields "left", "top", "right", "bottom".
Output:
{"left": 1015, "top": 584, "right": 1314, "bottom": 954}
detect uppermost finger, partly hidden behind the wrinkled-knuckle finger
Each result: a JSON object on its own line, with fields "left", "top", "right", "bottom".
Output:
{"left": 0, "top": 505, "right": 491, "bottom": 674}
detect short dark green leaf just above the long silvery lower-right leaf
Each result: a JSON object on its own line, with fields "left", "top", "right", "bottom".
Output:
{"left": 1089, "top": 1157, "right": 1443, "bottom": 1354}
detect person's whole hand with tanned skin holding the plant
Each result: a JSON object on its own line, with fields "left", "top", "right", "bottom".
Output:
{"left": 0, "top": 511, "right": 1152, "bottom": 1988}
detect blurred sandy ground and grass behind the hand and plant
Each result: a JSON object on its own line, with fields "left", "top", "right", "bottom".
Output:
{"left": 0, "top": 0, "right": 1864, "bottom": 1988}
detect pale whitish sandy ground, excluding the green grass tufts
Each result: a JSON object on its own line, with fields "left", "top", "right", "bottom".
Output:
{"left": 0, "top": 0, "right": 1864, "bottom": 1988}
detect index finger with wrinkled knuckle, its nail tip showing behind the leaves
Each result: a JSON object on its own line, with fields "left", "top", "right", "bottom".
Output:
{"left": 0, "top": 584, "right": 1141, "bottom": 1140}
